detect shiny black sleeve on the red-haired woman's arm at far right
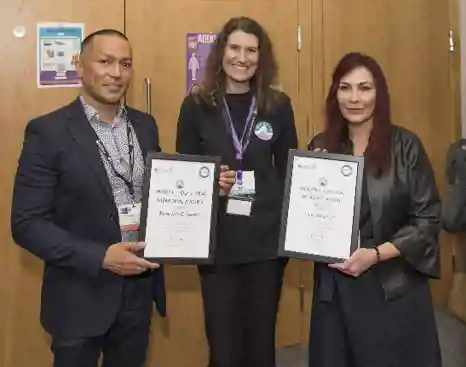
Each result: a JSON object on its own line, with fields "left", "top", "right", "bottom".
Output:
{"left": 390, "top": 136, "right": 441, "bottom": 276}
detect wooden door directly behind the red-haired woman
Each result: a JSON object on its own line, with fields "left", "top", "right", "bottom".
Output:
{"left": 303, "top": 0, "right": 455, "bottom": 344}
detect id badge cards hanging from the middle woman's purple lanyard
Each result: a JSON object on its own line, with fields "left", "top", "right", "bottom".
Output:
{"left": 227, "top": 171, "right": 256, "bottom": 216}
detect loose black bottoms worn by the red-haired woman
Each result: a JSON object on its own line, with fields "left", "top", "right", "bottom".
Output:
{"left": 309, "top": 270, "right": 442, "bottom": 367}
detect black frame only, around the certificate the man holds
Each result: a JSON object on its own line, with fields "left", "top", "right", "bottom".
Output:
{"left": 138, "top": 152, "right": 221, "bottom": 265}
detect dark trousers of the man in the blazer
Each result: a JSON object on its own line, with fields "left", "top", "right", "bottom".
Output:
{"left": 52, "top": 279, "right": 152, "bottom": 367}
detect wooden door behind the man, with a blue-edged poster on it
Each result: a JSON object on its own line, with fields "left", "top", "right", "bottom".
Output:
{"left": 0, "top": 0, "right": 124, "bottom": 367}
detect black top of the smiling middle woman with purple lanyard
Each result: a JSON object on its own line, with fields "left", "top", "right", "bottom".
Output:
{"left": 176, "top": 92, "right": 298, "bottom": 263}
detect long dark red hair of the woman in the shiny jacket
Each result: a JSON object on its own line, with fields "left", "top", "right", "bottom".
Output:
{"left": 324, "top": 52, "right": 392, "bottom": 176}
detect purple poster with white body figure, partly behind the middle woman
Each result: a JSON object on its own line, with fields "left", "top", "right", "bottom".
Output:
{"left": 186, "top": 33, "right": 217, "bottom": 93}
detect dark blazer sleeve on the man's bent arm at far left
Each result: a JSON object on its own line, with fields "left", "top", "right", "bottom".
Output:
{"left": 11, "top": 120, "right": 107, "bottom": 276}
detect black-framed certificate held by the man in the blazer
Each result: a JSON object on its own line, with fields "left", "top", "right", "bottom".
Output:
{"left": 139, "top": 152, "right": 220, "bottom": 264}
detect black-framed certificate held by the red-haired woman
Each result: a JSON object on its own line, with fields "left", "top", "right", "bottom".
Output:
{"left": 279, "top": 150, "right": 364, "bottom": 263}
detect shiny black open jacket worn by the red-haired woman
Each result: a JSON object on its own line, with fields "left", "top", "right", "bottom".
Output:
{"left": 309, "top": 126, "right": 441, "bottom": 299}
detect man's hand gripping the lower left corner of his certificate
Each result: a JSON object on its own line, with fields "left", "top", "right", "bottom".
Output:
{"left": 102, "top": 242, "right": 159, "bottom": 276}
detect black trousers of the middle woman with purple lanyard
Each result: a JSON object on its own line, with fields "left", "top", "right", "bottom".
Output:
{"left": 199, "top": 259, "right": 286, "bottom": 367}
